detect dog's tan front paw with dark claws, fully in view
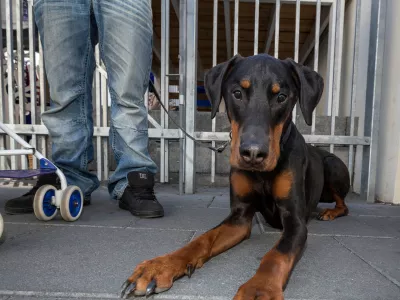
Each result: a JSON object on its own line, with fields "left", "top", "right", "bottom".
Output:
{"left": 121, "top": 255, "right": 193, "bottom": 298}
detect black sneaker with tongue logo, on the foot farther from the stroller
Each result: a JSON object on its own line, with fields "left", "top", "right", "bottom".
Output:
{"left": 119, "top": 172, "right": 164, "bottom": 218}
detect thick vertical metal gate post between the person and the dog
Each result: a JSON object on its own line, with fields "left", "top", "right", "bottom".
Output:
{"left": 185, "top": 0, "right": 198, "bottom": 194}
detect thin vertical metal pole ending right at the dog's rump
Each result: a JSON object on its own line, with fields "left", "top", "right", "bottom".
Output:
{"left": 348, "top": 0, "right": 361, "bottom": 186}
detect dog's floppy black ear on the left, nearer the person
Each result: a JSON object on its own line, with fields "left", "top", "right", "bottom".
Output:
{"left": 204, "top": 54, "right": 243, "bottom": 119}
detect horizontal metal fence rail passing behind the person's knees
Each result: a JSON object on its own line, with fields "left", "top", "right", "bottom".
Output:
{"left": 0, "top": 124, "right": 179, "bottom": 139}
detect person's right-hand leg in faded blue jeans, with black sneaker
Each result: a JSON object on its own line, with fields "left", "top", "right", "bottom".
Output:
{"left": 93, "top": 0, "right": 163, "bottom": 217}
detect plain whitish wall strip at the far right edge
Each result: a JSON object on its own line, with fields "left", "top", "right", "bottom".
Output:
{"left": 376, "top": 0, "right": 400, "bottom": 204}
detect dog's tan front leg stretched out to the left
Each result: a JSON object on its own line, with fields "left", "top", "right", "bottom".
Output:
{"left": 121, "top": 203, "right": 254, "bottom": 297}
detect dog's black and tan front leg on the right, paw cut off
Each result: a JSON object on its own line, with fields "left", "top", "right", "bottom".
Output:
{"left": 234, "top": 195, "right": 307, "bottom": 300}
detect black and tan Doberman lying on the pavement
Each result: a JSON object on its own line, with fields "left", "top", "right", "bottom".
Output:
{"left": 122, "top": 54, "right": 350, "bottom": 300}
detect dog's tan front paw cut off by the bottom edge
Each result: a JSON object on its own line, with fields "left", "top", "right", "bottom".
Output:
{"left": 233, "top": 274, "right": 284, "bottom": 300}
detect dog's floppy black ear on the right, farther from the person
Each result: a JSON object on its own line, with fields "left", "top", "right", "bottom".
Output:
{"left": 286, "top": 58, "right": 324, "bottom": 126}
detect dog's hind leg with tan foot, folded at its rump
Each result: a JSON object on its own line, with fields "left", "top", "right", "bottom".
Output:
{"left": 317, "top": 151, "right": 350, "bottom": 221}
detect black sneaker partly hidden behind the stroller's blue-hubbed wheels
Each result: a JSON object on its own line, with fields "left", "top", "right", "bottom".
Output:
{"left": 4, "top": 173, "right": 90, "bottom": 215}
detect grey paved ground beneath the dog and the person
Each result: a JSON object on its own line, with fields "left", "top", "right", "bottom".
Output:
{"left": 0, "top": 184, "right": 400, "bottom": 300}
